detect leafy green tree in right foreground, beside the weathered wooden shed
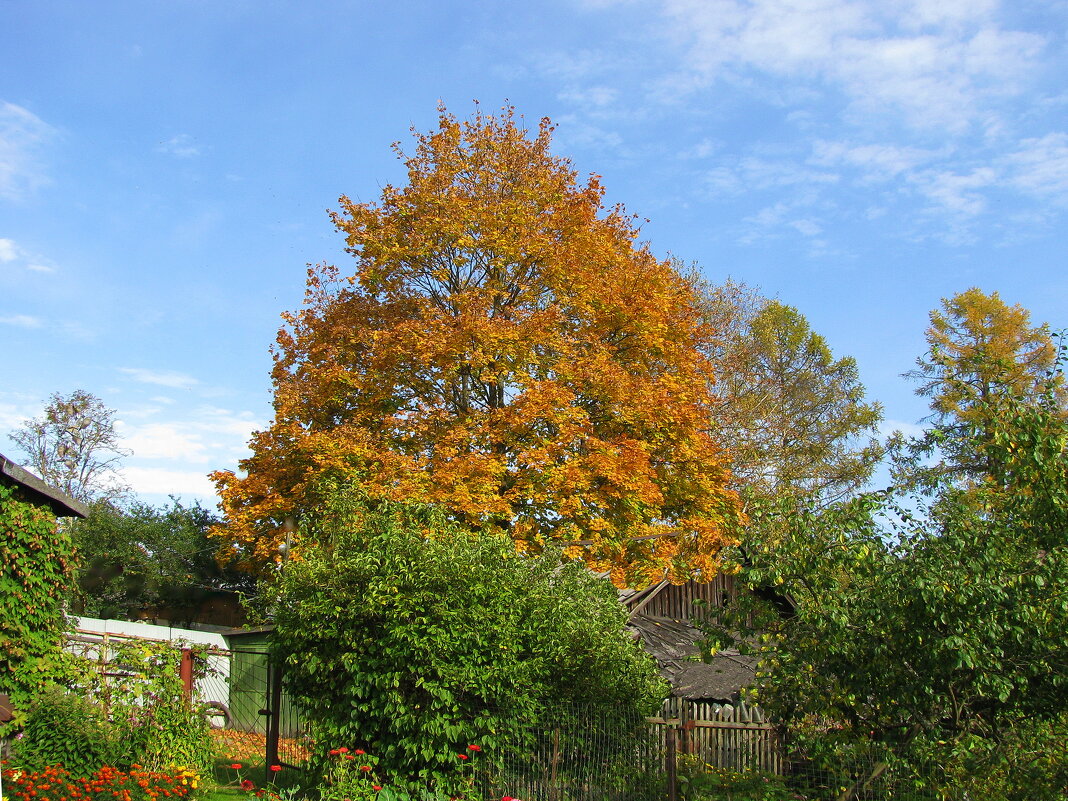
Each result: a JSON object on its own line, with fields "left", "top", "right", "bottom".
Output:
{"left": 713, "top": 358, "right": 1068, "bottom": 801}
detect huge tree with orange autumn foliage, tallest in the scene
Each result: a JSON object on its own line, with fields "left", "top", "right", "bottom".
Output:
{"left": 215, "top": 109, "right": 739, "bottom": 584}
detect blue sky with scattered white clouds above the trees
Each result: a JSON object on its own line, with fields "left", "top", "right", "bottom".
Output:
{"left": 0, "top": 0, "right": 1068, "bottom": 504}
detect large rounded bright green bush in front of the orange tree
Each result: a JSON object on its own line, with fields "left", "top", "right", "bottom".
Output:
{"left": 274, "top": 496, "right": 663, "bottom": 789}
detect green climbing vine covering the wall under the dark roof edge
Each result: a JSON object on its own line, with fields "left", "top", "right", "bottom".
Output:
{"left": 0, "top": 485, "right": 74, "bottom": 734}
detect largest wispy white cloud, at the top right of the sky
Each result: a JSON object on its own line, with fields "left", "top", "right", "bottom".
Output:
{"left": 664, "top": 0, "right": 1046, "bottom": 132}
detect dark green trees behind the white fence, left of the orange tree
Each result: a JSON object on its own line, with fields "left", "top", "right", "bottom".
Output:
{"left": 70, "top": 499, "right": 254, "bottom": 624}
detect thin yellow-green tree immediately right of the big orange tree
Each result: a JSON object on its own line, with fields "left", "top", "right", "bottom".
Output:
{"left": 702, "top": 292, "right": 882, "bottom": 503}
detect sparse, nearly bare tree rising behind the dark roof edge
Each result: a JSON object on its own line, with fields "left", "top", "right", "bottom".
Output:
{"left": 11, "top": 390, "right": 129, "bottom": 503}
